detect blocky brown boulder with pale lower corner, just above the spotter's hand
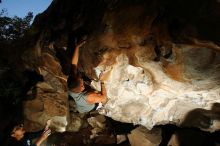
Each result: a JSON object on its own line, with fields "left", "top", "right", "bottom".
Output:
{"left": 24, "top": 83, "right": 68, "bottom": 132}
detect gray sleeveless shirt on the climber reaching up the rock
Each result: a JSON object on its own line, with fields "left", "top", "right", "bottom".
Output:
{"left": 68, "top": 91, "right": 95, "bottom": 113}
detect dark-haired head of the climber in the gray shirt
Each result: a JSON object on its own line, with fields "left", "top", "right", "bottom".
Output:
{"left": 67, "top": 75, "right": 85, "bottom": 93}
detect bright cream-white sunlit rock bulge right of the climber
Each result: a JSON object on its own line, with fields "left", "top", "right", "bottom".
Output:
{"left": 97, "top": 48, "right": 220, "bottom": 131}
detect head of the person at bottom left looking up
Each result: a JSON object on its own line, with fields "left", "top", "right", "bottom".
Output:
{"left": 10, "top": 124, "right": 25, "bottom": 141}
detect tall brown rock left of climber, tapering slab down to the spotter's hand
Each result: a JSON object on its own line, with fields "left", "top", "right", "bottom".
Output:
{"left": 24, "top": 53, "right": 69, "bottom": 132}
